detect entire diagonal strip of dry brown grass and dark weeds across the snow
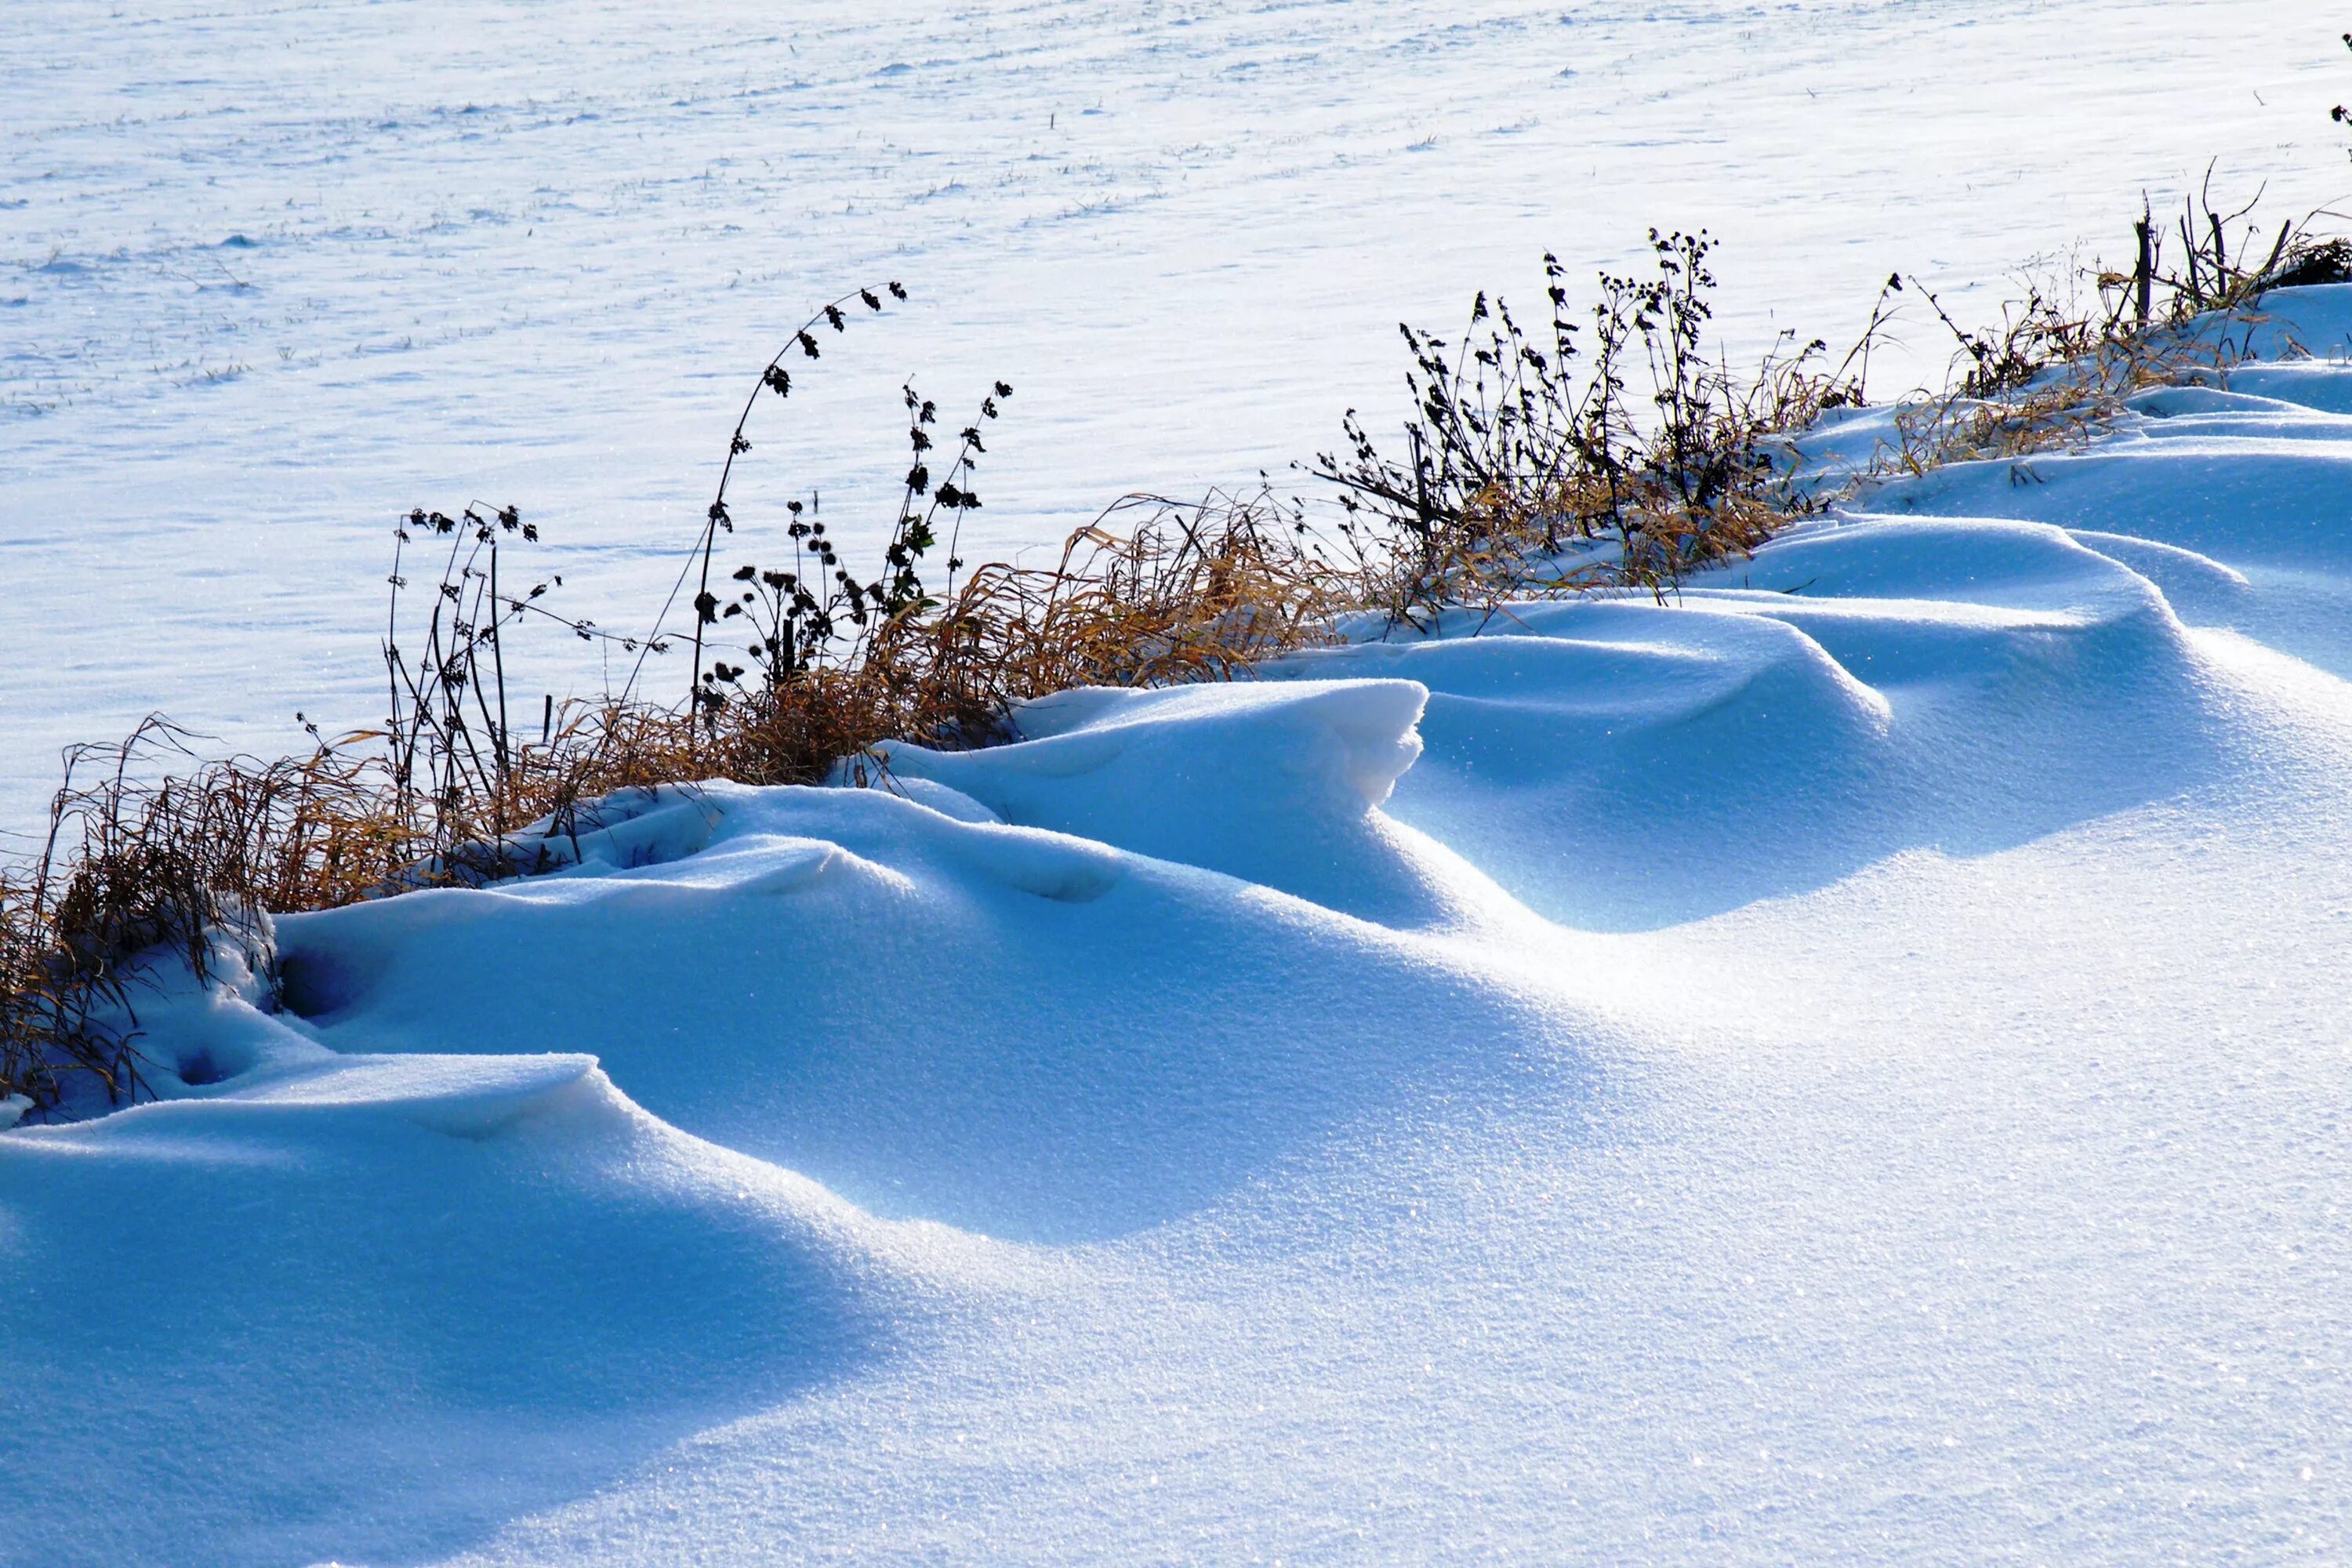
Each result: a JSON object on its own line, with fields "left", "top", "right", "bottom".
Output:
{"left": 13, "top": 175, "right": 2352, "bottom": 1114}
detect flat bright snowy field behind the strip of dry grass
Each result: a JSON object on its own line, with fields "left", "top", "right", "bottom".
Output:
{"left": 0, "top": 0, "right": 2352, "bottom": 832}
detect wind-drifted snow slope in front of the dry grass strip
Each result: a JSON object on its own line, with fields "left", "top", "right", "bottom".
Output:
{"left": 13, "top": 289, "right": 2352, "bottom": 1563}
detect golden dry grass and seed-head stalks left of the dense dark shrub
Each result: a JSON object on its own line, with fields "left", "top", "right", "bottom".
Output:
{"left": 0, "top": 282, "right": 1352, "bottom": 1114}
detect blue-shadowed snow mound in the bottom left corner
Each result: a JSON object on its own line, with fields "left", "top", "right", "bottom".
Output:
{"left": 0, "top": 1015, "right": 950, "bottom": 1563}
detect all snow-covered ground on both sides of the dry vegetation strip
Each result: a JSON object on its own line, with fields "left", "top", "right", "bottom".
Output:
{"left": 0, "top": 2, "right": 2352, "bottom": 1563}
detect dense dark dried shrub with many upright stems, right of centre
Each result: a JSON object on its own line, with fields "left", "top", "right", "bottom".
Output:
{"left": 1312, "top": 230, "right": 1867, "bottom": 626}
